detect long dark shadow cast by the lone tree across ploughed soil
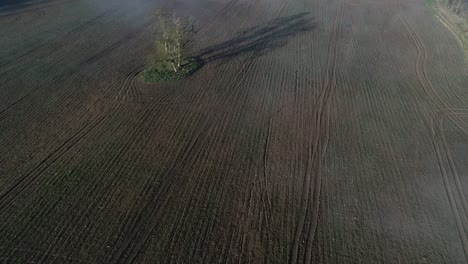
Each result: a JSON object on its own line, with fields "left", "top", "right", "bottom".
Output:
{"left": 195, "top": 12, "right": 316, "bottom": 64}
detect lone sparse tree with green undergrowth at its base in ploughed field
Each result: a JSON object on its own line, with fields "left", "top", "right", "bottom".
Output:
{"left": 143, "top": 8, "right": 198, "bottom": 82}
